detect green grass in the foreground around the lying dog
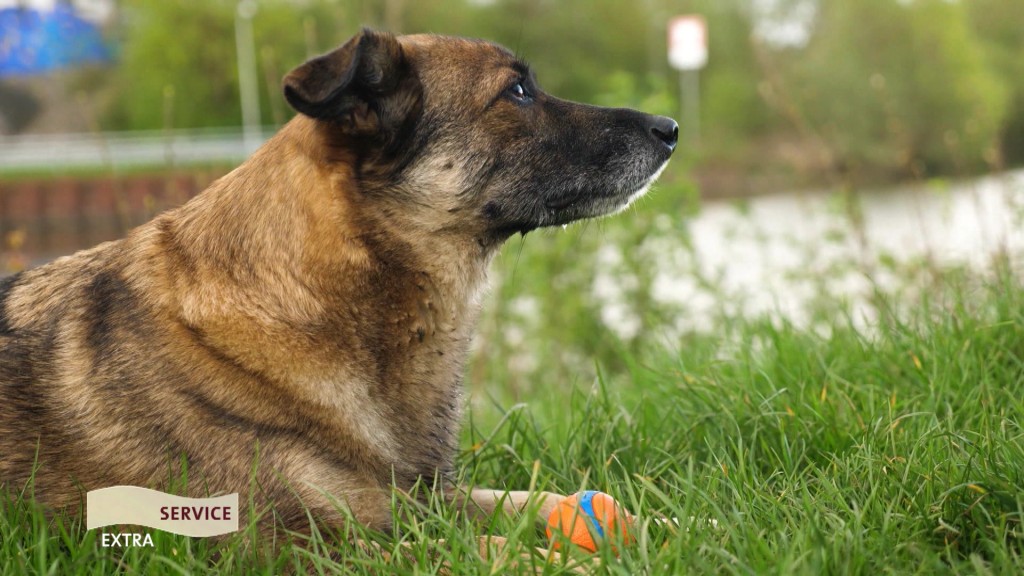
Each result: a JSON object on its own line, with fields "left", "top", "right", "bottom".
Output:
{"left": 0, "top": 264, "right": 1024, "bottom": 574}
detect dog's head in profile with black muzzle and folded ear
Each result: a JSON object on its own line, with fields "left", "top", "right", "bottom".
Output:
{"left": 285, "top": 30, "right": 678, "bottom": 244}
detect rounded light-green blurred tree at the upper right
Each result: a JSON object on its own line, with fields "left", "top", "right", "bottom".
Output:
{"left": 771, "top": 0, "right": 1007, "bottom": 175}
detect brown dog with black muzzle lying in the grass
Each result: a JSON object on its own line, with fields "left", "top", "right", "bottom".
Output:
{"left": 0, "top": 29, "right": 678, "bottom": 545}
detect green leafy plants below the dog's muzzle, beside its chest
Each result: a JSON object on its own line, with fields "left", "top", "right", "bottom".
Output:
{"left": 469, "top": 166, "right": 697, "bottom": 398}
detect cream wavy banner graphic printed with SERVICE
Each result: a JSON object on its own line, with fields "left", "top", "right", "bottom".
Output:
{"left": 85, "top": 486, "right": 239, "bottom": 536}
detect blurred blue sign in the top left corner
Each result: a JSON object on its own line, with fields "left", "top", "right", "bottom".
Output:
{"left": 0, "top": 2, "right": 114, "bottom": 77}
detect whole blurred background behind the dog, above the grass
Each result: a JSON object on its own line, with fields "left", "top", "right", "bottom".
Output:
{"left": 0, "top": 0, "right": 1024, "bottom": 398}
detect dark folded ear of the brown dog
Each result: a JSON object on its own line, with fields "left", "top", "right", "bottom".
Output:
{"left": 284, "top": 29, "right": 408, "bottom": 131}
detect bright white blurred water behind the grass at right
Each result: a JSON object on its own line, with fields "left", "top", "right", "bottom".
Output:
{"left": 594, "top": 171, "right": 1024, "bottom": 338}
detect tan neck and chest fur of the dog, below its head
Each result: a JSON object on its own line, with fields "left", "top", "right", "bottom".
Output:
{"left": 142, "top": 117, "right": 495, "bottom": 474}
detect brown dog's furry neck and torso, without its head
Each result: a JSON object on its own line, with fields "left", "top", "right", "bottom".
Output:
{"left": 0, "top": 117, "right": 473, "bottom": 524}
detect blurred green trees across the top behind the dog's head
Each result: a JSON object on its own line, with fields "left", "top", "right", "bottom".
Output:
{"left": 90, "top": 0, "right": 1024, "bottom": 177}
